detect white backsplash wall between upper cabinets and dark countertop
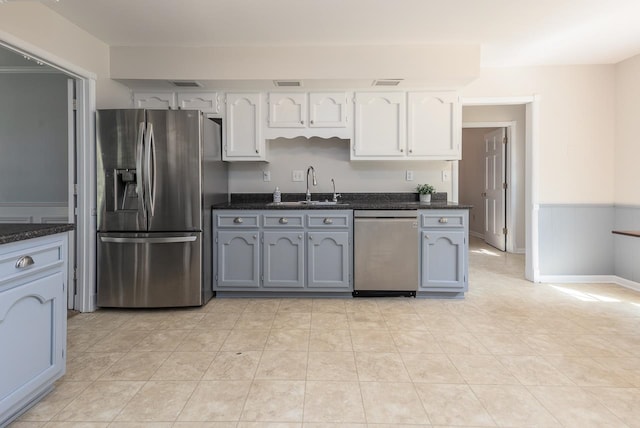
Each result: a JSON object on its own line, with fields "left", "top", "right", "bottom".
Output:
{"left": 229, "top": 138, "right": 451, "bottom": 195}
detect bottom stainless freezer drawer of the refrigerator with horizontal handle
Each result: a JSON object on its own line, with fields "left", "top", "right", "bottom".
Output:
{"left": 98, "top": 232, "right": 203, "bottom": 308}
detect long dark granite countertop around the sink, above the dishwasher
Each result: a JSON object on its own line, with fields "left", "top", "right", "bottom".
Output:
{"left": 212, "top": 193, "right": 472, "bottom": 210}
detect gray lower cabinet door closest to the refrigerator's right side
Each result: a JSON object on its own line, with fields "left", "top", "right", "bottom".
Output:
{"left": 217, "top": 230, "right": 260, "bottom": 288}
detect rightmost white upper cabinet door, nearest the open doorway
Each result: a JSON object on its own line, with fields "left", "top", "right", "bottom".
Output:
{"left": 407, "top": 92, "right": 462, "bottom": 160}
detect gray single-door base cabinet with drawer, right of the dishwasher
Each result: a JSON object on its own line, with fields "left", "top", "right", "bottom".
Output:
{"left": 418, "top": 210, "right": 469, "bottom": 297}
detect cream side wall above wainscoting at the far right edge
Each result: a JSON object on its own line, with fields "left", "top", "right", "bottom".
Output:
{"left": 615, "top": 55, "right": 640, "bottom": 205}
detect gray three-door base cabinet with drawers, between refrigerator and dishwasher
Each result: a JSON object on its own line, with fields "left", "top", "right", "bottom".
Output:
{"left": 212, "top": 210, "right": 353, "bottom": 292}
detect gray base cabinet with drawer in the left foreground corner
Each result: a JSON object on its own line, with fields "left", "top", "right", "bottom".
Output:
{"left": 0, "top": 233, "right": 68, "bottom": 426}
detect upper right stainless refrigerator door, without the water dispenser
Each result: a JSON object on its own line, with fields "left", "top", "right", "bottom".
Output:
{"left": 144, "top": 110, "right": 202, "bottom": 232}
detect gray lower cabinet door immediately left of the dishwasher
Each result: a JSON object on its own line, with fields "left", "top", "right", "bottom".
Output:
{"left": 307, "top": 232, "right": 351, "bottom": 288}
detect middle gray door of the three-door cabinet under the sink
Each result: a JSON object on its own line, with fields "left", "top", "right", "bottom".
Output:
{"left": 263, "top": 231, "right": 304, "bottom": 288}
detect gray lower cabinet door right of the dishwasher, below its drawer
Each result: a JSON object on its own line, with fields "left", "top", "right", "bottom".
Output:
{"left": 420, "top": 229, "right": 466, "bottom": 291}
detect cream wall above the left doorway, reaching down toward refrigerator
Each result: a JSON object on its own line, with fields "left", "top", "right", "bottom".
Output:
{"left": 0, "top": 2, "right": 130, "bottom": 108}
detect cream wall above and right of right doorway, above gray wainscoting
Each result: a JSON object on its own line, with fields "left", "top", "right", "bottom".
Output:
{"left": 462, "top": 65, "right": 616, "bottom": 204}
